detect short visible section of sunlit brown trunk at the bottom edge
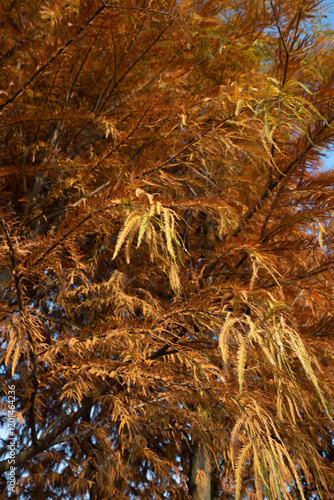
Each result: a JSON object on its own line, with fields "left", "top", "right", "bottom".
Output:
{"left": 189, "top": 440, "right": 211, "bottom": 500}
